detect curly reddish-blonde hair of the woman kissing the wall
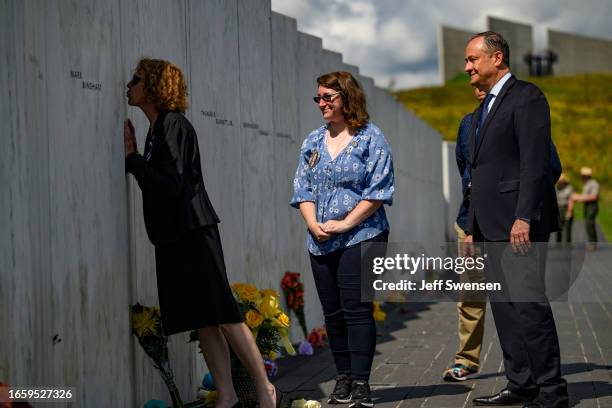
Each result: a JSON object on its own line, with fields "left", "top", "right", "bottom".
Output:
{"left": 136, "top": 58, "right": 188, "bottom": 113}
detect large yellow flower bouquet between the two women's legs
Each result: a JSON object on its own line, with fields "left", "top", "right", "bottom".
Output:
{"left": 232, "top": 283, "right": 295, "bottom": 357}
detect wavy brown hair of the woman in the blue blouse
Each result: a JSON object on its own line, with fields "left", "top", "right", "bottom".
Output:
{"left": 317, "top": 71, "right": 370, "bottom": 129}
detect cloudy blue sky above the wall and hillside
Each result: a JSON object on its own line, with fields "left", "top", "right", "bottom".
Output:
{"left": 272, "top": 0, "right": 612, "bottom": 89}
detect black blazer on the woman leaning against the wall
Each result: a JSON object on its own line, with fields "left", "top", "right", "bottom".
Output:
{"left": 125, "top": 111, "right": 219, "bottom": 245}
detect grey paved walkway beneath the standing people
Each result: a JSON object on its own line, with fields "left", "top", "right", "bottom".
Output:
{"left": 274, "top": 224, "right": 612, "bottom": 408}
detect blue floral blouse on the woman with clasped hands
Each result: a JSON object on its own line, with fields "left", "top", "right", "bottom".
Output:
{"left": 291, "top": 122, "right": 394, "bottom": 255}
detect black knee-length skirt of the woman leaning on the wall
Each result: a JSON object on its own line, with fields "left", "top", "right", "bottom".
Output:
{"left": 155, "top": 225, "right": 244, "bottom": 335}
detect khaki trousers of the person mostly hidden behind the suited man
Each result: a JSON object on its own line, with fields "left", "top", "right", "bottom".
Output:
{"left": 455, "top": 223, "right": 487, "bottom": 370}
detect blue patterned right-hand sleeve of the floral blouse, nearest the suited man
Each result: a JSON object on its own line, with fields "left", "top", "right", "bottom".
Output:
{"left": 361, "top": 132, "right": 395, "bottom": 205}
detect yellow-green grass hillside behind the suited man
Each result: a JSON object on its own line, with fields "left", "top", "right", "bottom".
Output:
{"left": 396, "top": 74, "right": 612, "bottom": 241}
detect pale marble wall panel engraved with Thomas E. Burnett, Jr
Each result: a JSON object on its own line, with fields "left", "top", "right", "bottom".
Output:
{"left": 188, "top": 1, "right": 246, "bottom": 282}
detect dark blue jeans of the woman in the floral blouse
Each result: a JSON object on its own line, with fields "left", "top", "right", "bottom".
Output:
{"left": 310, "top": 231, "right": 389, "bottom": 380}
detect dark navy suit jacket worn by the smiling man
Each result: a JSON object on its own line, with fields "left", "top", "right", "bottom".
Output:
{"left": 468, "top": 76, "right": 559, "bottom": 241}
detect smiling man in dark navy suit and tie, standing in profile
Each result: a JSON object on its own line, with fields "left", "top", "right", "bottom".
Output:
{"left": 465, "top": 31, "right": 568, "bottom": 408}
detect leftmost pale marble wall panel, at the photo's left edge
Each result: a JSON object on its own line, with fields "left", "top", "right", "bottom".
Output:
{"left": 0, "top": 0, "right": 52, "bottom": 384}
